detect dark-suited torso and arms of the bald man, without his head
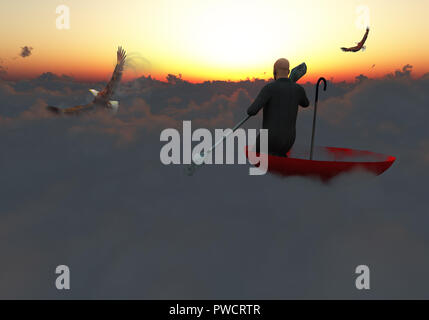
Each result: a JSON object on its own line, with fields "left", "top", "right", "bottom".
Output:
{"left": 247, "top": 78, "right": 310, "bottom": 155}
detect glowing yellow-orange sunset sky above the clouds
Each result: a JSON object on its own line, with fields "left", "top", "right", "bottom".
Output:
{"left": 0, "top": 0, "right": 429, "bottom": 82}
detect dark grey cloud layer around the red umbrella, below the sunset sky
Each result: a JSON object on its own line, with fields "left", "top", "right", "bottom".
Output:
{"left": 0, "top": 66, "right": 429, "bottom": 299}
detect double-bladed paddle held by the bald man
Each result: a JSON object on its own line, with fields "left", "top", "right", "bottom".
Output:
{"left": 185, "top": 62, "right": 307, "bottom": 176}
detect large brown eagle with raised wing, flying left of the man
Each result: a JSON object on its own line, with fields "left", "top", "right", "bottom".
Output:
{"left": 46, "top": 47, "right": 127, "bottom": 115}
